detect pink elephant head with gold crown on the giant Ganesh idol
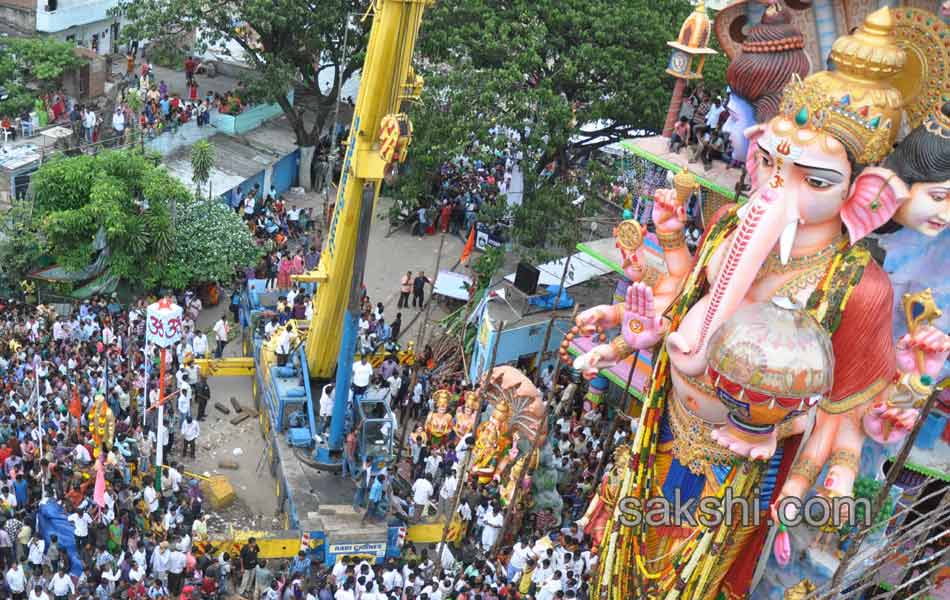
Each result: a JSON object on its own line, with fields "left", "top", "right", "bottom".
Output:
{"left": 669, "top": 9, "right": 906, "bottom": 375}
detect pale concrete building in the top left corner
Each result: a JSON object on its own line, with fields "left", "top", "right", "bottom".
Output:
{"left": 0, "top": 0, "right": 121, "bottom": 54}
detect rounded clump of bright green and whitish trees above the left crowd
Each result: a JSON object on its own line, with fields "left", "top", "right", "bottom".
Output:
{"left": 33, "top": 151, "right": 260, "bottom": 289}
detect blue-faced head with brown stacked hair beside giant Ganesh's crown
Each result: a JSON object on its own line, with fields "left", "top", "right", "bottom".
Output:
{"left": 723, "top": 3, "right": 809, "bottom": 169}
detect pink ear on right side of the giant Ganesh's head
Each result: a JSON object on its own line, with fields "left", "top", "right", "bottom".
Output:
{"left": 841, "top": 167, "right": 910, "bottom": 245}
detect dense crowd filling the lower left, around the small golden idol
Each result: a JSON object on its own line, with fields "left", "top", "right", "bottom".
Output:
{"left": 0, "top": 293, "right": 245, "bottom": 599}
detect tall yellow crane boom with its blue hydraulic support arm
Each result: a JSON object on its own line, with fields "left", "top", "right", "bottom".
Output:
{"left": 297, "top": 0, "right": 433, "bottom": 459}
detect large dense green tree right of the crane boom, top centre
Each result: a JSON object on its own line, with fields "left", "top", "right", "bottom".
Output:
{"left": 396, "top": 0, "right": 692, "bottom": 260}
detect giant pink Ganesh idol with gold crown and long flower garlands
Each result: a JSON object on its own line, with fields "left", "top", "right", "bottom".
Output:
{"left": 585, "top": 9, "right": 950, "bottom": 600}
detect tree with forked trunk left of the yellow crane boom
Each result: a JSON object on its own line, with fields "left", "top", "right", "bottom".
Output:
{"left": 116, "top": 0, "right": 370, "bottom": 188}
